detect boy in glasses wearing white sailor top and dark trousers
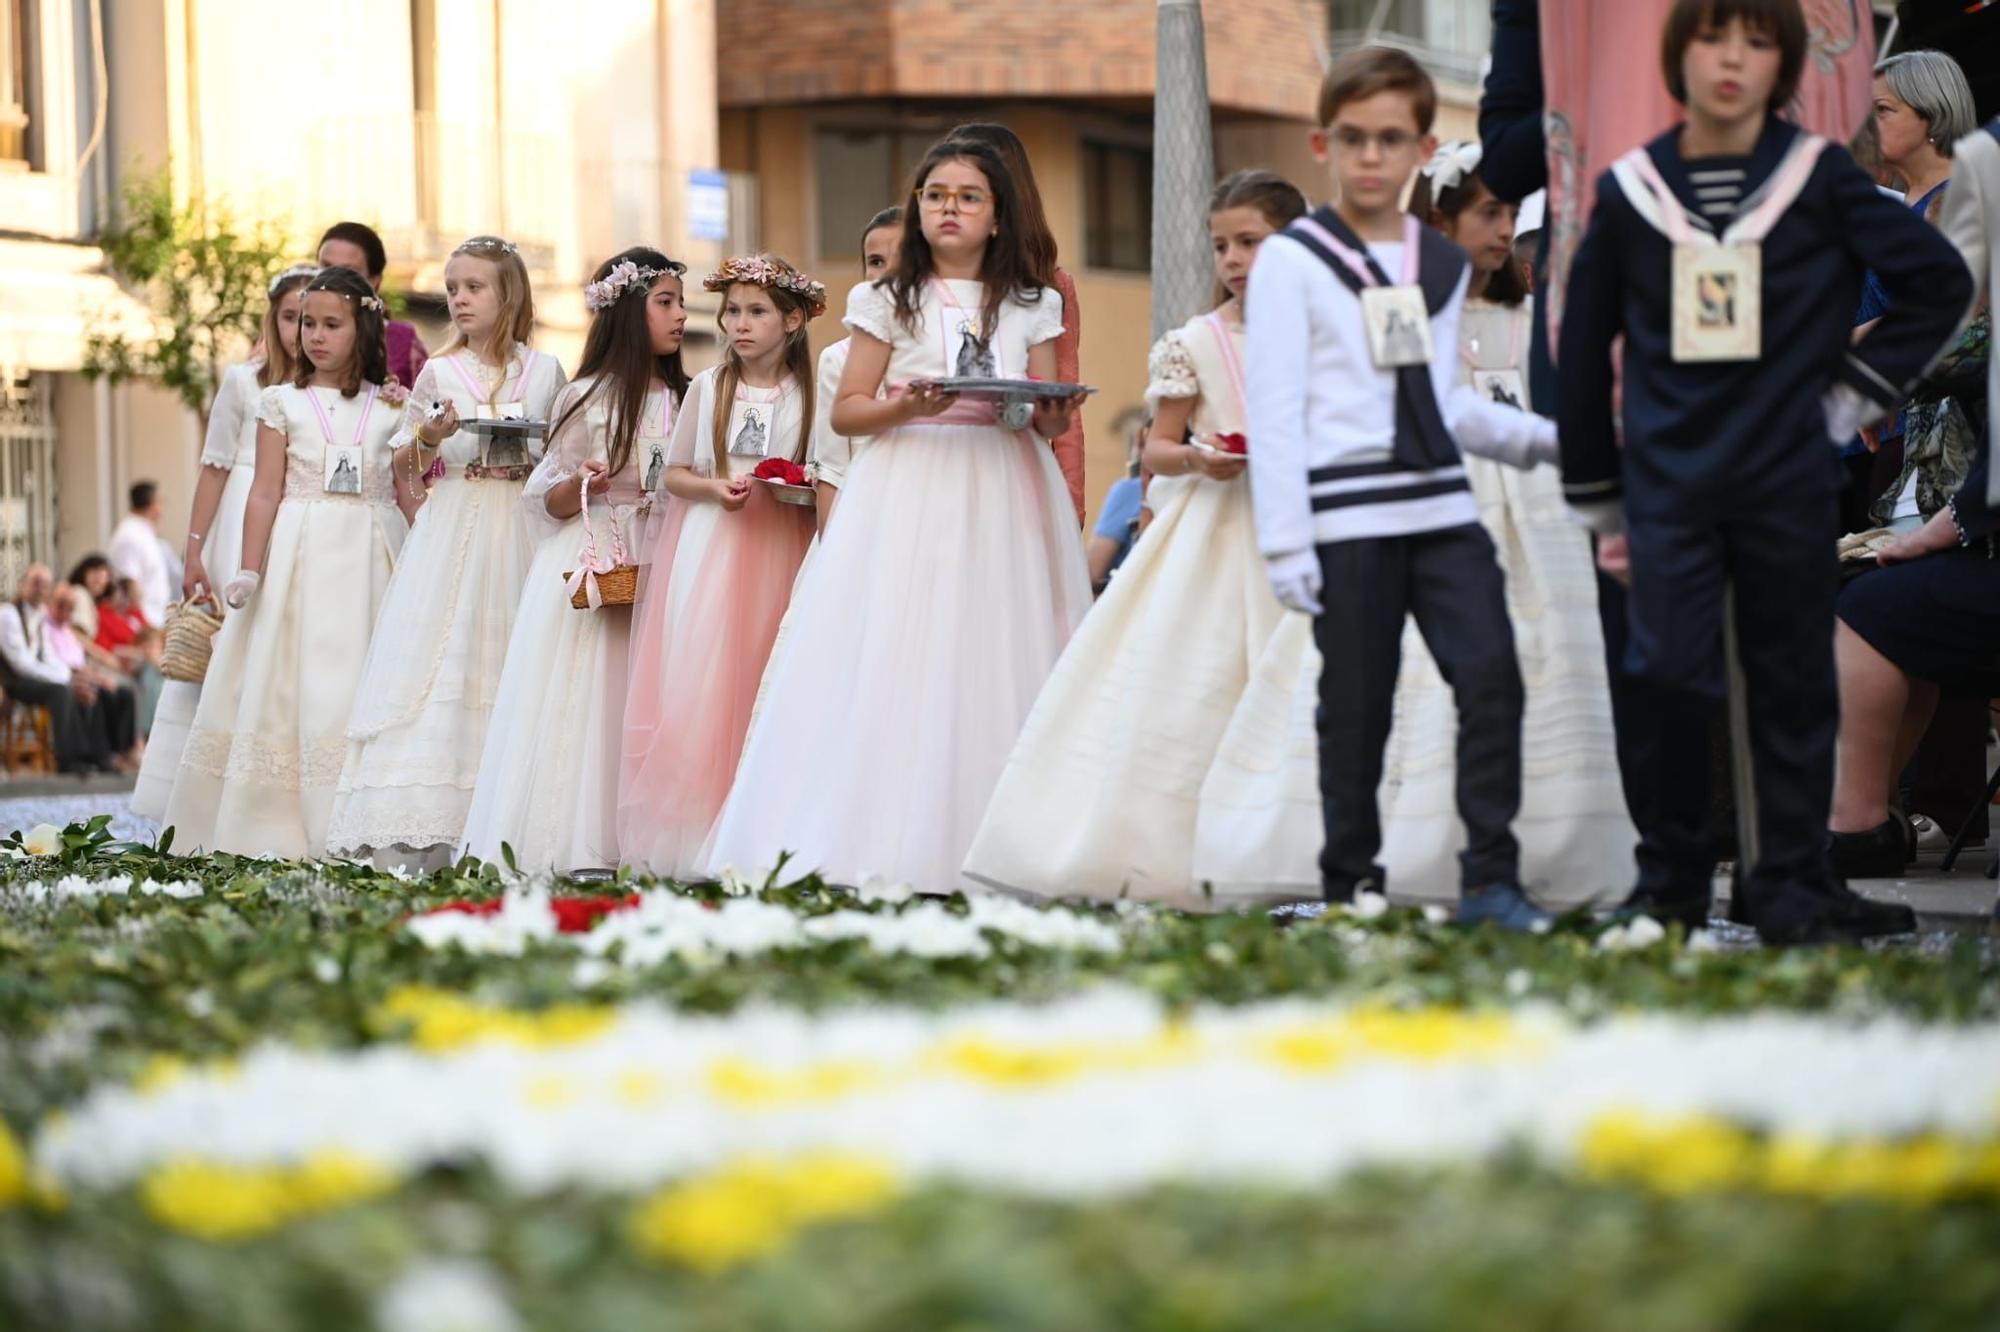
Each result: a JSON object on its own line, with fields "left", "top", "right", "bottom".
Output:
{"left": 1244, "top": 46, "right": 1556, "bottom": 930}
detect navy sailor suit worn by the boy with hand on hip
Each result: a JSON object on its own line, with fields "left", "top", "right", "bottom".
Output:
{"left": 1556, "top": 118, "right": 1970, "bottom": 920}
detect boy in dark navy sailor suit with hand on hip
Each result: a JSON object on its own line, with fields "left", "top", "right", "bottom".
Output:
{"left": 1558, "top": 0, "right": 1970, "bottom": 944}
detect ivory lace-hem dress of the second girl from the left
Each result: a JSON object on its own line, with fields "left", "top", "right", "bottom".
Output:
{"left": 166, "top": 384, "right": 406, "bottom": 858}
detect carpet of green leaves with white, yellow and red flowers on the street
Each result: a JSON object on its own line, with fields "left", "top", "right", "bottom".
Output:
{"left": 0, "top": 808, "right": 2000, "bottom": 1332}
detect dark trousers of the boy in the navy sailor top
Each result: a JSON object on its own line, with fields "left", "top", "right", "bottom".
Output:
{"left": 1626, "top": 496, "right": 1840, "bottom": 904}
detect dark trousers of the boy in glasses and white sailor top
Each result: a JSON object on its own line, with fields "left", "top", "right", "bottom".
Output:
{"left": 1314, "top": 524, "right": 1522, "bottom": 900}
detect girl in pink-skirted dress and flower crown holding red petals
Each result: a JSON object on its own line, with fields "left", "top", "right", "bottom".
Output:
{"left": 618, "top": 254, "right": 826, "bottom": 878}
